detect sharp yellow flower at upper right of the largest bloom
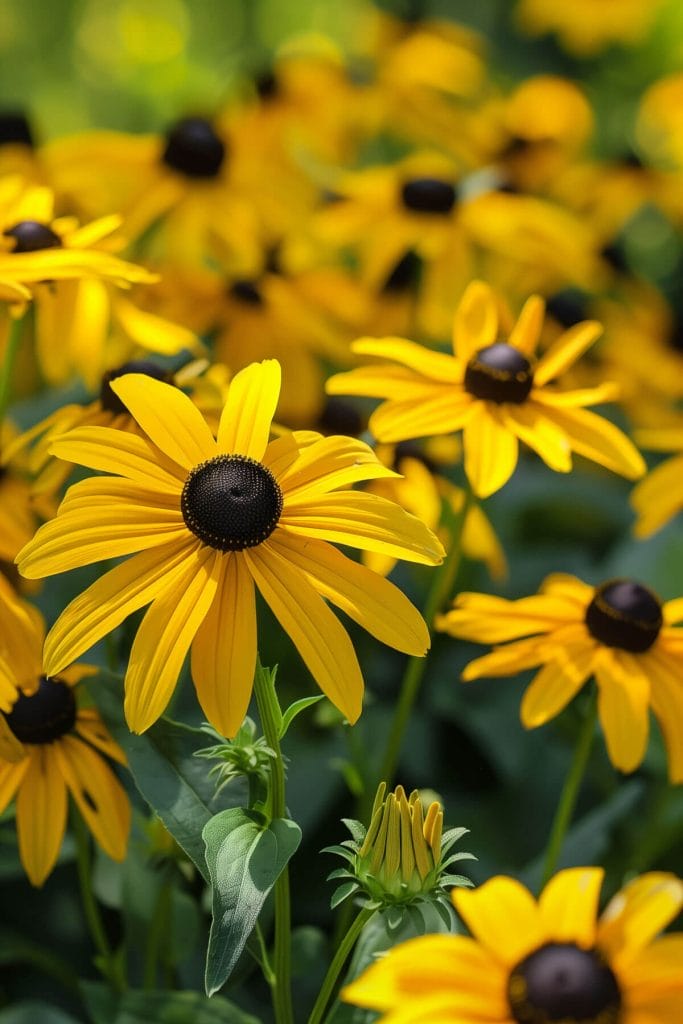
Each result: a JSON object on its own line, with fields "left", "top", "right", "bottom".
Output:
{"left": 327, "top": 281, "right": 645, "bottom": 498}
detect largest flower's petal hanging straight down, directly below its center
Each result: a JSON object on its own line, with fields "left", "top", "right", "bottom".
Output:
{"left": 191, "top": 552, "right": 257, "bottom": 736}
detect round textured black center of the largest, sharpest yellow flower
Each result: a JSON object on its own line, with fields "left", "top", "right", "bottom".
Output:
{"left": 180, "top": 455, "right": 283, "bottom": 551}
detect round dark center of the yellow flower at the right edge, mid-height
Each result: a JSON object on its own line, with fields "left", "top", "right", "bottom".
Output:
{"left": 586, "top": 580, "right": 664, "bottom": 654}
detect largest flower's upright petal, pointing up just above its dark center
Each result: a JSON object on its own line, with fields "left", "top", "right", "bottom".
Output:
{"left": 218, "top": 359, "right": 281, "bottom": 462}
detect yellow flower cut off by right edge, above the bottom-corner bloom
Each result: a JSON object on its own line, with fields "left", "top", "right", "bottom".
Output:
{"left": 436, "top": 573, "right": 683, "bottom": 782}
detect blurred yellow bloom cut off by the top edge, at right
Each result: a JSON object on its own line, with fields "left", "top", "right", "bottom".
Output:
{"left": 515, "top": 0, "right": 663, "bottom": 57}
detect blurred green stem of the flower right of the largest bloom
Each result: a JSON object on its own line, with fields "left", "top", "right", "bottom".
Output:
{"left": 370, "top": 486, "right": 472, "bottom": 798}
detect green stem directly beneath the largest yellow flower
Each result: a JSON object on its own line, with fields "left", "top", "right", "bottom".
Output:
{"left": 254, "top": 660, "right": 294, "bottom": 1024}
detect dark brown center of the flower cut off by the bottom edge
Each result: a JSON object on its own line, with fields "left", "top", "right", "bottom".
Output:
{"left": 508, "top": 942, "right": 622, "bottom": 1024}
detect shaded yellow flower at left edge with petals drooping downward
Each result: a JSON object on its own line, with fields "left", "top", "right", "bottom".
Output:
{"left": 0, "top": 578, "right": 130, "bottom": 886}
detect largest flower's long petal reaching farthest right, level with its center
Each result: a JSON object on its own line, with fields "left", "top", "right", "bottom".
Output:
{"left": 280, "top": 492, "right": 443, "bottom": 565}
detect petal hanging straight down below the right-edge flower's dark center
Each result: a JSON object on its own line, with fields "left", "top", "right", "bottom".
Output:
{"left": 594, "top": 648, "right": 650, "bottom": 772}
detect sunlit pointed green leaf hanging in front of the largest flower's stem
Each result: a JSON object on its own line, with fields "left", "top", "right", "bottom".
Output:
{"left": 202, "top": 808, "right": 301, "bottom": 995}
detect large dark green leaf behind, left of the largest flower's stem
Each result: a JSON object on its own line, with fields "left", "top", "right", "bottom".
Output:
{"left": 89, "top": 672, "right": 247, "bottom": 881}
